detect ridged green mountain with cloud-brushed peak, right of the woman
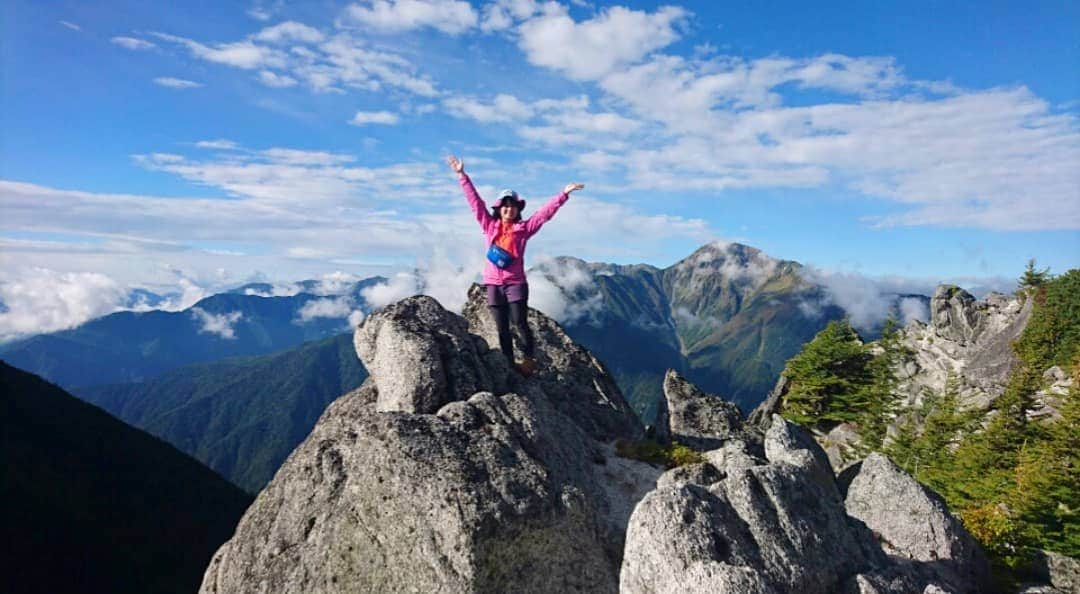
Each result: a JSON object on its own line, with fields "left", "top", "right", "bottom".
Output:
{"left": 536, "top": 243, "right": 843, "bottom": 421}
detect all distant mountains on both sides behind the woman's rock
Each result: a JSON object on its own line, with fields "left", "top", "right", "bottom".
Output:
{"left": 0, "top": 243, "right": 924, "bottom": 492}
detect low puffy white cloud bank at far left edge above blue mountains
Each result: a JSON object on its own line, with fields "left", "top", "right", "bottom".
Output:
{"left": 0, "top": 268, "right": 127, "bottom": 342}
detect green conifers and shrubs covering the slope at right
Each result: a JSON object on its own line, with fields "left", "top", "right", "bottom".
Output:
{"left": 782, "top": 270, "right": 1080, "bottom": 589}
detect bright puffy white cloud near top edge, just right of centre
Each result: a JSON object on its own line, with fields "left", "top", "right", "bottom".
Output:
{"left": 518, "top": 6, "right": 689, "bottom": 80}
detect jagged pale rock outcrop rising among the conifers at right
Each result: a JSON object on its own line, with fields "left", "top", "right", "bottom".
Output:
{"left": 897, "top": 285, "right": 1032, "bottom": 409}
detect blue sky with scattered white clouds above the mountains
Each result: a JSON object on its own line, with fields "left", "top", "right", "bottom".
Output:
{"left": 0, "top": 0, "right": 1080, "bottom": 335}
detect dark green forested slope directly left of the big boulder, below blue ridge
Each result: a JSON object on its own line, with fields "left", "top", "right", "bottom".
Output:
{"left": 77, "top": 334, "right": 367, "bottom": 492}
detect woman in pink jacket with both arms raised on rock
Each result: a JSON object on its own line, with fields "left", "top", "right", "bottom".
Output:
{"left": 446, "top": 156, "right": 584, "bottom": 376}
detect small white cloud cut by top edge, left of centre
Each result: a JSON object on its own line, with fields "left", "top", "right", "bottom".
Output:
{"left": 342, "top": 0, "right": 478, "bottom": 35}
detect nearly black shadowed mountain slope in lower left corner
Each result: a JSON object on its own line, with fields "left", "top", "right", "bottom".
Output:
{"left": 0, "top": 362, "right": 251, "bottom": 594}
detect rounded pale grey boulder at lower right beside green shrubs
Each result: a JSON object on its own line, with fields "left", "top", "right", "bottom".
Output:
{"left": 845, "top": 454, "right": 989, "bottom": 593}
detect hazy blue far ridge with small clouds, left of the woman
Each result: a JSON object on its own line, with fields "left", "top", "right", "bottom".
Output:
{"left": 0, "top": 276, "right": 384, "bottom": 393}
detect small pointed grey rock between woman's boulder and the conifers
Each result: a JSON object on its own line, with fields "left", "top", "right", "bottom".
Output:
{"left": 657, "top": 369, "right": 743, "bottom": 449}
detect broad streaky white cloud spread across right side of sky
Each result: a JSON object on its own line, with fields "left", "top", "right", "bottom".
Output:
{"left": 586, "top": 49, "right": 1080, "bottom": 230}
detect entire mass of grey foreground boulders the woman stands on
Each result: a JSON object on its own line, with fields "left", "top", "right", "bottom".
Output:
{"left": 201, "top": 287, "right": 986, "bottom": 594}
